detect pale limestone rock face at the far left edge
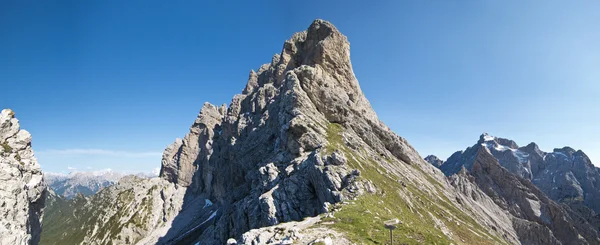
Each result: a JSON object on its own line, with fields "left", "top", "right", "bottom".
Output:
{"left": 0, "top": 109, "right": 46, "bottom": 244}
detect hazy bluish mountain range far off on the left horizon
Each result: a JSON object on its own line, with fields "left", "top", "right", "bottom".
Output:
{"left": 44, "top": 169, "right": 158, "bottom": 199}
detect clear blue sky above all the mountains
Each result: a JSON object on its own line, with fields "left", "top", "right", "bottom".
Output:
{"left": 0, "top": 0, "right": 600, "bottom": 172}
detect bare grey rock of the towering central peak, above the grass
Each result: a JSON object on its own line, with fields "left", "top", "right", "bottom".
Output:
{"left": 160, "top": 20, "right": 429, "bottom": 241}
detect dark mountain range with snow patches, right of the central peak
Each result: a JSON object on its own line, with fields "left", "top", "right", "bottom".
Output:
{"left": 425, "top": 133, "right": 600, "bottom": 244}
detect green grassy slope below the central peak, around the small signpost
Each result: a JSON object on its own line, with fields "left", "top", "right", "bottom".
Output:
{"left": 321, "top": 124, "right": 506, "bottom": 244}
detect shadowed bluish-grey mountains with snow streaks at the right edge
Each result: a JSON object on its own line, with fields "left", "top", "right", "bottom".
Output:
{"left": 440, "top": 134, "right": 600, "bottom": 244}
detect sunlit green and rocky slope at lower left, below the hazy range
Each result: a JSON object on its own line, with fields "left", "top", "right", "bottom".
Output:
{"left": 40, "top": 175, "right": 191, "bottom": 244}
